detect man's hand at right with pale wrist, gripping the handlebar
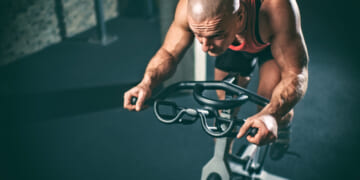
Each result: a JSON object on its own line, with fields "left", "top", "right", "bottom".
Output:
{"left": 236, "top": 115, "right": 278, "bottom": 146}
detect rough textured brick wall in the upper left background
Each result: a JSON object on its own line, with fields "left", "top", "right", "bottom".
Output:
{"left": 0, "top": 0, "right": 118, "bottom": 65}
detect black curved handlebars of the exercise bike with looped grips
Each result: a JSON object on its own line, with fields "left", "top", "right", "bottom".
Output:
{"left": 131, "top": 81, "right": 269, "bottom": 137}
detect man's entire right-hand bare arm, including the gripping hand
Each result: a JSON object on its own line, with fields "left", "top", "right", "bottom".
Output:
{"left": 237, "top": 0, "right": 308, "bottom": 145}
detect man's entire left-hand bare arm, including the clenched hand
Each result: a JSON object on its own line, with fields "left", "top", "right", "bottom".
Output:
{"left": 124, "top": 0, "right": 193, "bottom": 111}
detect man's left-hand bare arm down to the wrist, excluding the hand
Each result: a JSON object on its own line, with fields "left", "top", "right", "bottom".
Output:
{"left": 142, "top": 0, "right": 193, "bottom": 88}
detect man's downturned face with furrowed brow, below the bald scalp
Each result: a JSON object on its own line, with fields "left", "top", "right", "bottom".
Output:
{"left": 188, "top": 14, "right": 237, "bottom": 56}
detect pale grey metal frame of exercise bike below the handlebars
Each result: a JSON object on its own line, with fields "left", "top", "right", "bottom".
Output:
{"left": 201, "top": 74, "right": 285, "bottom": 180}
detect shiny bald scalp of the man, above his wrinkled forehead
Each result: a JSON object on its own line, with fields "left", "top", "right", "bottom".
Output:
{"left": 187, "top": 0, "right": 240, "bottom": 22}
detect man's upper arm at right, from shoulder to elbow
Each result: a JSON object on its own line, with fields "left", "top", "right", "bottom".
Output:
{"left": 269, "top": 0, "right": 308, "bottom": 74}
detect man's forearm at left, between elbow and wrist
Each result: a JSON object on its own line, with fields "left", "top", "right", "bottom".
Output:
{"left": 141, "top": 48, "right": 179, "bottom": 89}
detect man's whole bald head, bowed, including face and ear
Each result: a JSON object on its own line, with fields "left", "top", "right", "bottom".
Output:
{"left": 187, "top": 0, "right": 246, "bottom": 56}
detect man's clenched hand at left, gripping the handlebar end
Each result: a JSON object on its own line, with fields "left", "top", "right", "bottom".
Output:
{"left": 124, "top": 83, "right": 151, "bottom": 111}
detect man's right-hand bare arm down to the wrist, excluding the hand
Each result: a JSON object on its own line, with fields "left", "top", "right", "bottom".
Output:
{"left": 260, "top": 0, "right": 308, "bottom": 124}
